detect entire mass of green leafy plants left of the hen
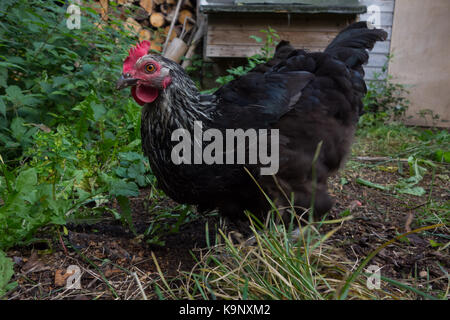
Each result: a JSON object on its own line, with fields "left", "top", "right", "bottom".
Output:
{"left": 0, "top": 0, "right": 158, "bottom": 249}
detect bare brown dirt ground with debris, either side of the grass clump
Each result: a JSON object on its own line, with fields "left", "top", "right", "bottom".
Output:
{"left": 7, "top": 162, "right": 450, "bottom": 299}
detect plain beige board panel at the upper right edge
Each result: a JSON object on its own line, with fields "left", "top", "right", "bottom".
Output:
{"left": 389, "top": 0, "right": 450, "bottom": 127}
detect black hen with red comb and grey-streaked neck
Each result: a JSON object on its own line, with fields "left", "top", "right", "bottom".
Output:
{"left": 118, "top": 22, "right": 387, "bottom": 219}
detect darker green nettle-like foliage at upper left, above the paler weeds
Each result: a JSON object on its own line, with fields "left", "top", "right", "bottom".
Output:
{"left": 0, "top": 0, "right": 135, "bottom": 161}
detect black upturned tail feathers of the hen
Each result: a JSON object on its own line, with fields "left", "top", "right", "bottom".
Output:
{"left": 325, "top": 21, "right": 387, "bottom": 69}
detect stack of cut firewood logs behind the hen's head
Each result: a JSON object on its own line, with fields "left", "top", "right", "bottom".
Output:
{"left": 84, "top": 0, "right": 196, "bottom": 52}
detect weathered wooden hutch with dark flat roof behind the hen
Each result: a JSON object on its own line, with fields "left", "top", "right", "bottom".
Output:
{"left": 200, "top": 0, "right": 366, "bottom": 58}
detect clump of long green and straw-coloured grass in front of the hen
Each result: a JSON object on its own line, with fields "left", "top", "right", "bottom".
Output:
{"left": 153, "top": 212, "right": 411, "bottom": 300}
